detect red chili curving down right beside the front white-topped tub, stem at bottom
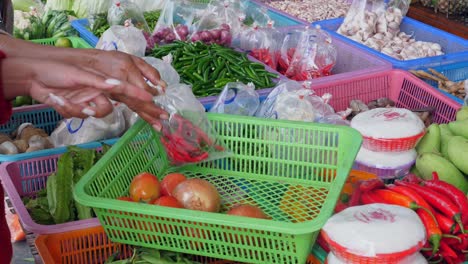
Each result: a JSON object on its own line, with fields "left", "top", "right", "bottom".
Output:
{"left": 387, "top": 185, "right": 442, "bottom": 253}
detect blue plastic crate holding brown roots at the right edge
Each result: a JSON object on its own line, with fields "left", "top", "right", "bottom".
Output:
{"left": 417, "top": 60, "right": 468, "bottom": 104}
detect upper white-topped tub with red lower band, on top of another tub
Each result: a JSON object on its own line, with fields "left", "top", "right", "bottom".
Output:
{"left": 351, "top": 107, "right": 426, "bottom": 152}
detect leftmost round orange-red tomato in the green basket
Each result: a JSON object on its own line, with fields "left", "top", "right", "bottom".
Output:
{"left": 130, "top": 172, "right": 160, "bottom": 202}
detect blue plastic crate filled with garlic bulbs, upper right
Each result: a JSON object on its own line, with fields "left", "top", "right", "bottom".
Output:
{"left": 313, "top": 17, "right": 468, "bottom": 70}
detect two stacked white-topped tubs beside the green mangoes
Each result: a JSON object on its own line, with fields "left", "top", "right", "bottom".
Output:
{"left": 351, "top": 108, "right": 425, "bottom": 180}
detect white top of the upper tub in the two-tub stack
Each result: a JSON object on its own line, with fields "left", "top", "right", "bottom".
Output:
{"left": 351, "top": 107, "right": 425, "bottom": 139}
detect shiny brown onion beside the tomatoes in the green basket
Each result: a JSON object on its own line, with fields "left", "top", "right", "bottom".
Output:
{"left": 172, "top": 178, "right": 221, "bottom": 212}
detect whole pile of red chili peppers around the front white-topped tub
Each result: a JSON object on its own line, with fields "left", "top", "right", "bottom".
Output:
{"left": 334, "top": 173, "right": 468, "bottom": 264}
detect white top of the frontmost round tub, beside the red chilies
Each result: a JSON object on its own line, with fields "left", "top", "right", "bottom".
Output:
{"left": 322, "top": 203, "right": 426, "bottom": 257}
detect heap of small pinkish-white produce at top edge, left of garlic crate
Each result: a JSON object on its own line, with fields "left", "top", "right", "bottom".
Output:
{"left": 263, "top": 0, "right": 350, "bottom": 23}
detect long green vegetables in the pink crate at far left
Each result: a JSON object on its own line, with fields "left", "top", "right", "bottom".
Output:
{"left": 23, "top": 145, "right": 110, "bottom": 225}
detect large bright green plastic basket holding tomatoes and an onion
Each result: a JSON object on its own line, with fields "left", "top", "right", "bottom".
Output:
{"left": 74, "top": 113, "right": 362, "bottom": 264}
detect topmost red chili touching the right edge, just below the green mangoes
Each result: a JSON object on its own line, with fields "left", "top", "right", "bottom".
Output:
{"left": 423, "top": 172, "right": 468, "bottom": 225}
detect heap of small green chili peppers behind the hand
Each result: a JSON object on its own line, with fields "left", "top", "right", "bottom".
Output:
{"left": 151, "top": 41, "right": 278, "bottom": 97}
